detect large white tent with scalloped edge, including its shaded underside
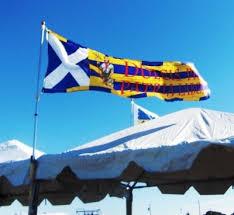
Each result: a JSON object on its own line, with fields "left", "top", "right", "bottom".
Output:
{"left": 0, "top": 108, "right": 234, "bottom": 214}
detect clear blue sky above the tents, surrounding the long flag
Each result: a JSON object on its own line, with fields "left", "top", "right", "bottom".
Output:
{"left": 0, "top": 0, "right": 234, "bottom": 214}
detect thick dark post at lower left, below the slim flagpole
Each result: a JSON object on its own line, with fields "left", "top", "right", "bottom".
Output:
{"left": 28, "top": 157, "right": 39, "bottom": 215}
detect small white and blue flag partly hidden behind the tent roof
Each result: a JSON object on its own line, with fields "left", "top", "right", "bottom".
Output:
{"left": 131, "top": 101, "right": 159, "bottom": 125}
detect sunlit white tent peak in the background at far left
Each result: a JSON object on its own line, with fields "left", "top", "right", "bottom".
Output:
{"left": 0, "top": 140, "right": 45, "bottom": 163}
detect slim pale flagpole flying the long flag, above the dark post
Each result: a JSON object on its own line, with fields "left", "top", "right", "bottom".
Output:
{"left": 32, "top": 21, "right": 45, "bottom": 160}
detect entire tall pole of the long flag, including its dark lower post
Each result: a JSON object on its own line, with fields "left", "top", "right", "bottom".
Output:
{"left": 28, "top": 21, "right": 46, "bottom": 215}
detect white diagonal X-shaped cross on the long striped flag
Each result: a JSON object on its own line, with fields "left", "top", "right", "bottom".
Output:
{"left": 44, "top": 34, "right": 89, "bottom": 89}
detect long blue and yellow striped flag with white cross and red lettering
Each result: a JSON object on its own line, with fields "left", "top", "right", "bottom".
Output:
{"left": 43, "top": 30, "right": 210, "bottom": 101}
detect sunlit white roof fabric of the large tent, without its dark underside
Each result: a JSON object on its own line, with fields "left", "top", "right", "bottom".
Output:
{"left": 37, "top": 109, "right": 234, "bottom": 180}
